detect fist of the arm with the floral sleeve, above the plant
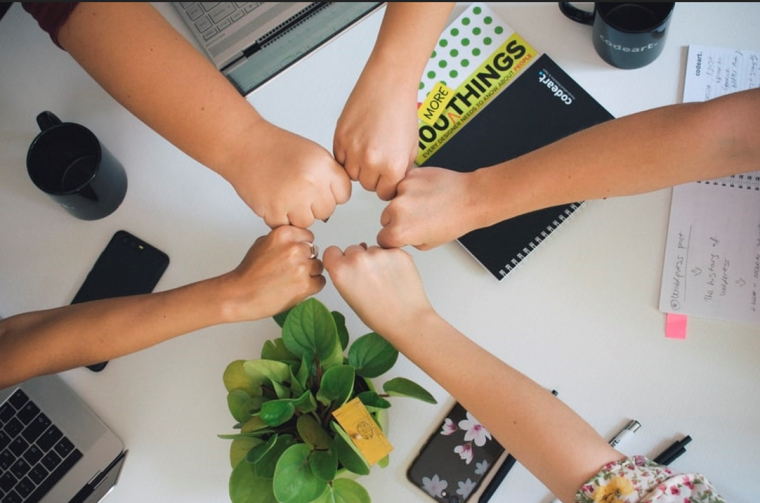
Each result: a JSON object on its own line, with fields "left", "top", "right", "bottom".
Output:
{"left": 324, "top": 244, "right": 433, "bottom": 339}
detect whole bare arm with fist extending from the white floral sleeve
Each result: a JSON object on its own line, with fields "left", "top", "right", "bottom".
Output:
{"left": 324, "top": 245, "right": 625, "bottom": 502}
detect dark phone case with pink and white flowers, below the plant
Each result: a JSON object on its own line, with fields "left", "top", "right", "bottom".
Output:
{"left": 406, "top": 402, "right": 506, "bottom": 503}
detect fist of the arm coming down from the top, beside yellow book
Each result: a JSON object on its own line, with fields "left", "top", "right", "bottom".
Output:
{"left": 333, "top": 63, "right": 418, "bottom": 201}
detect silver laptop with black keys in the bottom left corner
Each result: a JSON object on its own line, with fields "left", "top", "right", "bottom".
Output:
{"left": 0, "top": 375, "right": 127, "bottom": 503}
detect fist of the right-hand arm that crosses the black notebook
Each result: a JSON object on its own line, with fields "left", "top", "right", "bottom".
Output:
{"left": 377, "top": 167, "right": 480, "bottom": 250}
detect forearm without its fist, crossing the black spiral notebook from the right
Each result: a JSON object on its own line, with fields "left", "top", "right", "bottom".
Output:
{"left": 473, "top": 90, "right": 760, "bottom": 227}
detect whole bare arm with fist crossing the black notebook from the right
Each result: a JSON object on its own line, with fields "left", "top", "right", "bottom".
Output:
{"left": 378, "top": 89, "right": 760, "bottom": 249}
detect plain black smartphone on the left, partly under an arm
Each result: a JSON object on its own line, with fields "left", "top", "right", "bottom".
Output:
{"left": 71, "top": 230, "right": 169, "bottom": 372}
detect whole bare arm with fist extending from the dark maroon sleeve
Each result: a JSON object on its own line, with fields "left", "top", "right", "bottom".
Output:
{"left": 58, "top": 2, "right": 351, "bottom": 227}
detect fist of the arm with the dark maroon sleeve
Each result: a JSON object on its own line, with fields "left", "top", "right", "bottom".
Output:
{"left": 227, "top": 120, "right": 351, "bottom": 229}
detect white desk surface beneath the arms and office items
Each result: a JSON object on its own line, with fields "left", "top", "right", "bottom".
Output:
{"left": 0, "top": 3, "right": 760, "bottom": 503}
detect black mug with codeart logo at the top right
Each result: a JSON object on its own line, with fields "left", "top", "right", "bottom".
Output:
{"left": 559, "top": 2, "right": 676, "bottom": 69}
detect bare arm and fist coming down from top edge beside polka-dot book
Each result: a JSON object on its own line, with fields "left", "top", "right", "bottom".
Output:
{"left": 333, "top": 2, "right": 455, "bottom": 201}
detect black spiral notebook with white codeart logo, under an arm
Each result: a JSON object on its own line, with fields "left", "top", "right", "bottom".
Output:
{"left": 418, "top": 54, "right": 613, "bottom": 280}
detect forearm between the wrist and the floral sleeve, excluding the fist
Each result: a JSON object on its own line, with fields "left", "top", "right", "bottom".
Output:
{"left": 392, "top": 313, "right": 624, "bottom": 502}
